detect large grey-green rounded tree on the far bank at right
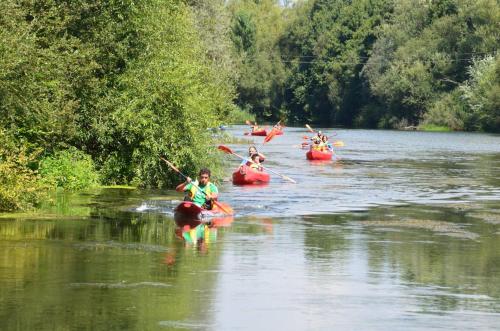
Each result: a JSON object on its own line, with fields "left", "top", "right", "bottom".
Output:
{"left": 363, "top": 0, "right": 500, "bottom": 129}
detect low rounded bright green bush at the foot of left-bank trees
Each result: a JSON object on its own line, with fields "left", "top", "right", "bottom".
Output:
{"left": 40, "top": 148, "right": 99, "bottom": 190}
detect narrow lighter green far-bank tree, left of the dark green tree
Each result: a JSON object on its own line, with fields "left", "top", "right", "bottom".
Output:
{"left": 228, "top": 0, "right": 290, "bottom": 120}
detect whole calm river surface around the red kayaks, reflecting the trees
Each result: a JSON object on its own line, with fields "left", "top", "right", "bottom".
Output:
{"left": 0, "top": 126, "right": 500, "bottom": 330}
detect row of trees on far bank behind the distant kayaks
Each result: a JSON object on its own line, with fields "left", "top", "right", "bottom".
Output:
{"left": 234, "top": 0, "right": 500, "bottom": 132}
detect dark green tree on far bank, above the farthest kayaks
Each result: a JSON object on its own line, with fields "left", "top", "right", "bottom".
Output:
{"left": 281, "top": 0, "right": 391, "bottom": 125}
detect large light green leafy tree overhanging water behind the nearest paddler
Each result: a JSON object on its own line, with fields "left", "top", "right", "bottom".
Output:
{"left": 99, "top": 0, "right": 230, "bottom": 187}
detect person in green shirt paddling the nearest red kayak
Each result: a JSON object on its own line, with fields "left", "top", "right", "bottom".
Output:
{"left": 175, "top": 168, "right": 219, "bottom": 209}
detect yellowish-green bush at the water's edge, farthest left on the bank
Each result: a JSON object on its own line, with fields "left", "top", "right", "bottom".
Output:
{"left": 0, "top": 129, "right": 46, "bottom": 211}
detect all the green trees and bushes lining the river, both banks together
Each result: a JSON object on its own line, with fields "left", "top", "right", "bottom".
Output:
{"left": 0, "top": 0, "right": 500, "bottom": 210}
